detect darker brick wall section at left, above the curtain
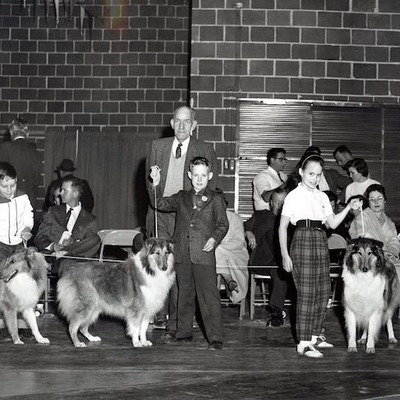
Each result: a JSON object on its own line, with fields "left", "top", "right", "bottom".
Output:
{"left": 0, "top": 0, "right": 189, "bottom": 134}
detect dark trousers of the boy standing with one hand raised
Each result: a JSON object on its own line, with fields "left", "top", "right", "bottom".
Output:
{"left": 175, "top": 255, "right": 224, "bottom": 343}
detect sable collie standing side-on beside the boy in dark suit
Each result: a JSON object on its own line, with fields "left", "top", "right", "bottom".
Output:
{"left": 57, "top": 239, "right": 175, "bottom": 347}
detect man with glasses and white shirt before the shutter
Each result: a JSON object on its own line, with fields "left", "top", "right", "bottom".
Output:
{"left": 253, "top": 147, "right": 287, "bottom": 211}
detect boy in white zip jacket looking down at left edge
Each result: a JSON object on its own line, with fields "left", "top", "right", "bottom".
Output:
{"left": 0, "top": 162, "right": 33, "bottom": 261}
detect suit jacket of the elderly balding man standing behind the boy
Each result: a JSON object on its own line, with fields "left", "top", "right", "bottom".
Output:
{"left": 146, "top": 136, "right": 218, "bottom": 193}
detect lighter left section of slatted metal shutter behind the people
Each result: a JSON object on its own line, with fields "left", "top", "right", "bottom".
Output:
{"left": 235, "top": 99, "right": 310, "bottom": 218}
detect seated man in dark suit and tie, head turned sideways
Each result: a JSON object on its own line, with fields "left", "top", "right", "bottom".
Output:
{"left": 35, "top": 176, "right": 100, "bottom": 270}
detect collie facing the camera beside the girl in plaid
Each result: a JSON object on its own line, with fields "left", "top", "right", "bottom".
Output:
{"left": 342, "top": 238, "right": 400, "bottom": 354}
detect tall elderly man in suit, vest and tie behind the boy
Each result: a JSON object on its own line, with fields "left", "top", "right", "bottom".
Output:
{"left": 146, "top": 106, "right": 218, "bottom": 340}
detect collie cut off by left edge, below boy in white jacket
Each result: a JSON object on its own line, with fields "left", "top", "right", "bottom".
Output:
{"left": 0, "top": 248, "right": 50, "bottom": 344}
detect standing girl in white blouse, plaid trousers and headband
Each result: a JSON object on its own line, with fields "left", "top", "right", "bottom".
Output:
{"left": 279, "top": 154, "right": 360, "bottom": 358}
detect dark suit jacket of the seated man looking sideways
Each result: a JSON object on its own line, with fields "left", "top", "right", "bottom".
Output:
{"left": 35, "top": 204, "right": 100, "bottom": 250}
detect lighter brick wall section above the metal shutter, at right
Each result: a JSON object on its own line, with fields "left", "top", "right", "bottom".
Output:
{"left": 190, "top": 0, "right": 400, "bottom": 204}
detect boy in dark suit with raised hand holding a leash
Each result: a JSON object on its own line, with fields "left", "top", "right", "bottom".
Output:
{"left": 150, "top": 157, "right": 229, "bottom": 350}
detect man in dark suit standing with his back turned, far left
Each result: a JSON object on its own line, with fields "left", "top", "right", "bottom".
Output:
{"left": 0, "top": 118, "right": 42, "bottom": 210}
